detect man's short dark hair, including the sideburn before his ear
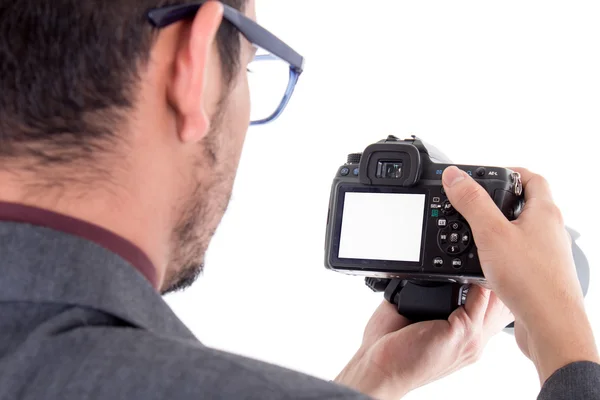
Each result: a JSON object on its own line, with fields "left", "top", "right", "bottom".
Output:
{"left": 0, "top": 0, "right": 245, "bottom": 168}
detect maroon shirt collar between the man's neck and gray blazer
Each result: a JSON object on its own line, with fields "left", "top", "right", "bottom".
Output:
{"left": 0, "top": 201, "right": 158, "bottom": 288}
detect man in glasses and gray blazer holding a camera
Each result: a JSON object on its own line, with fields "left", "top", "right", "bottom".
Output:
{"left": 0, "top": 0, "right": 600, "bottom": 399}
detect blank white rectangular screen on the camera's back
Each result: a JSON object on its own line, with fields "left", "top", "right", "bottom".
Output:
{"left": 338, "top": 192, "right": 425, "bottom": 262}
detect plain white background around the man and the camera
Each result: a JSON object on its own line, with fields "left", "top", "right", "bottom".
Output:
{"left": 168, "top": 0, "right": 600, "bottom": 400}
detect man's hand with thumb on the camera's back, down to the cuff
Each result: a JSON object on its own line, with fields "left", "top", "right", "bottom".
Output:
{"left": 443, "top": 167, "right": 600, "bottom": 384}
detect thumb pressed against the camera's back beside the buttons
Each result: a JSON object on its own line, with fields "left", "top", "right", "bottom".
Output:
{"left": 442, "top": 166, "right": 511, "bottom": 248}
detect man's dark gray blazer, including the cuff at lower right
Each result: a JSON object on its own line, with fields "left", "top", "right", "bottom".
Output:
{"left": 0, "top": 222, "right": 600, "bottom": 400}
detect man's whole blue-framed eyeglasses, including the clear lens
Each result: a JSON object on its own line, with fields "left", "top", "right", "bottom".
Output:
{"left": 147, "top": 0, "right": 304, "bottom": 125}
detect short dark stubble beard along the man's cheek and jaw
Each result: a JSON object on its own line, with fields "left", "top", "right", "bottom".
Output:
{"left": 161, "top": 96, "right": 235, "bottom": 295}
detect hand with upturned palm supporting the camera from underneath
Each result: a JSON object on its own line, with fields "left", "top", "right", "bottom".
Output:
{"left": 335, "top": 286, "right": 514, "bottom": 399}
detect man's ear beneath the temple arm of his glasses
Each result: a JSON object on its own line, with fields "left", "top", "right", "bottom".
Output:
{"left": 169, "top": 1, "right": 223, "bottom": 142}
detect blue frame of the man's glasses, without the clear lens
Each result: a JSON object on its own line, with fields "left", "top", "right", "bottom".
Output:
{"left": 147, "top": 0, "right": 304, "bottom": 125}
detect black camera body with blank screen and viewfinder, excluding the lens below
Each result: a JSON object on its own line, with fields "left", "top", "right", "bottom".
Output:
{"left": 325, "top": 136, "right": 524, "bottom": 286}
